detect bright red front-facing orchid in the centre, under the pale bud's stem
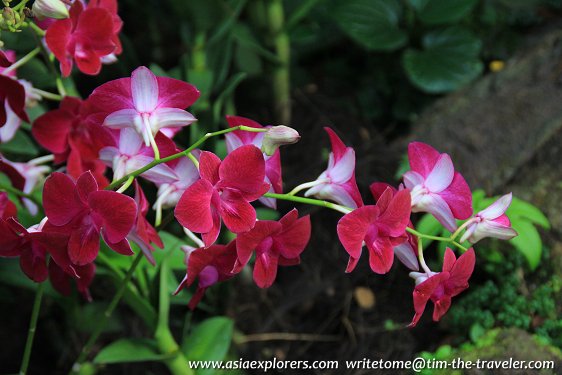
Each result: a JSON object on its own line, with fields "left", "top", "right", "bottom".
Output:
{"left": 175, "top": 145, "right": 269, "bottom": 247}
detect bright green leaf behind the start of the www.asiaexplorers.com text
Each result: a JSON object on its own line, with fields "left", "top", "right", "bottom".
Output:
{"left": 181, "top": 317, "right": 234, "bottom": 368}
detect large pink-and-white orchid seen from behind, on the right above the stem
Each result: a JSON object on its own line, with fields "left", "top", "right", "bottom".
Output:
{"left": 404, "top": 142, "right": 472, "bottom": 232}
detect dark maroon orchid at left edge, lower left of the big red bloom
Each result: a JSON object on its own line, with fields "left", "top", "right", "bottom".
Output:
{"left": 0, "top": 217, "right": 75, "bottom": 282}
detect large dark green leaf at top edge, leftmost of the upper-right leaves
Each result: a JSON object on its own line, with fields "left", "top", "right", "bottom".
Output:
{"left": 333, "top": 0, "right": 408, "bottom": 51}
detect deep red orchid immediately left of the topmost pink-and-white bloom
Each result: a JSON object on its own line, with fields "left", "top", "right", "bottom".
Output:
{"left": 31, "top": 96, "right": 115, "bottom": 187}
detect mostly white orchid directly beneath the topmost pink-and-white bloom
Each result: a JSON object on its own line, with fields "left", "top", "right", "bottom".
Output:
{"left": 100, "top": 128, "right": 174, "bottom": 180}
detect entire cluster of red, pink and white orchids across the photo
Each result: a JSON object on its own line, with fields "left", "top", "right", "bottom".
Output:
{"left": 0, "top": 0, "right": 517, "bottom": 326}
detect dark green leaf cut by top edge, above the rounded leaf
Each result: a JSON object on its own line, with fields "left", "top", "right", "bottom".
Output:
{"left": 409, "top": 0, "right": 478, "bottom": 25}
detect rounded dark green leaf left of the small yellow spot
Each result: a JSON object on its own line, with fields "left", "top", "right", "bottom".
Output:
{"left": 402, "top": 27, "right": 484, "bottom": 93}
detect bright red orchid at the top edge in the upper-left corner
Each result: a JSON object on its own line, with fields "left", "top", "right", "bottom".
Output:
{"left": 45, "top": 0, "right": 121, "bottom": 77}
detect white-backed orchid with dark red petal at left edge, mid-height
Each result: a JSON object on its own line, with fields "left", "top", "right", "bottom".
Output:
{"left": 0, "top": 155, "right": 51, "bottom": 215}
